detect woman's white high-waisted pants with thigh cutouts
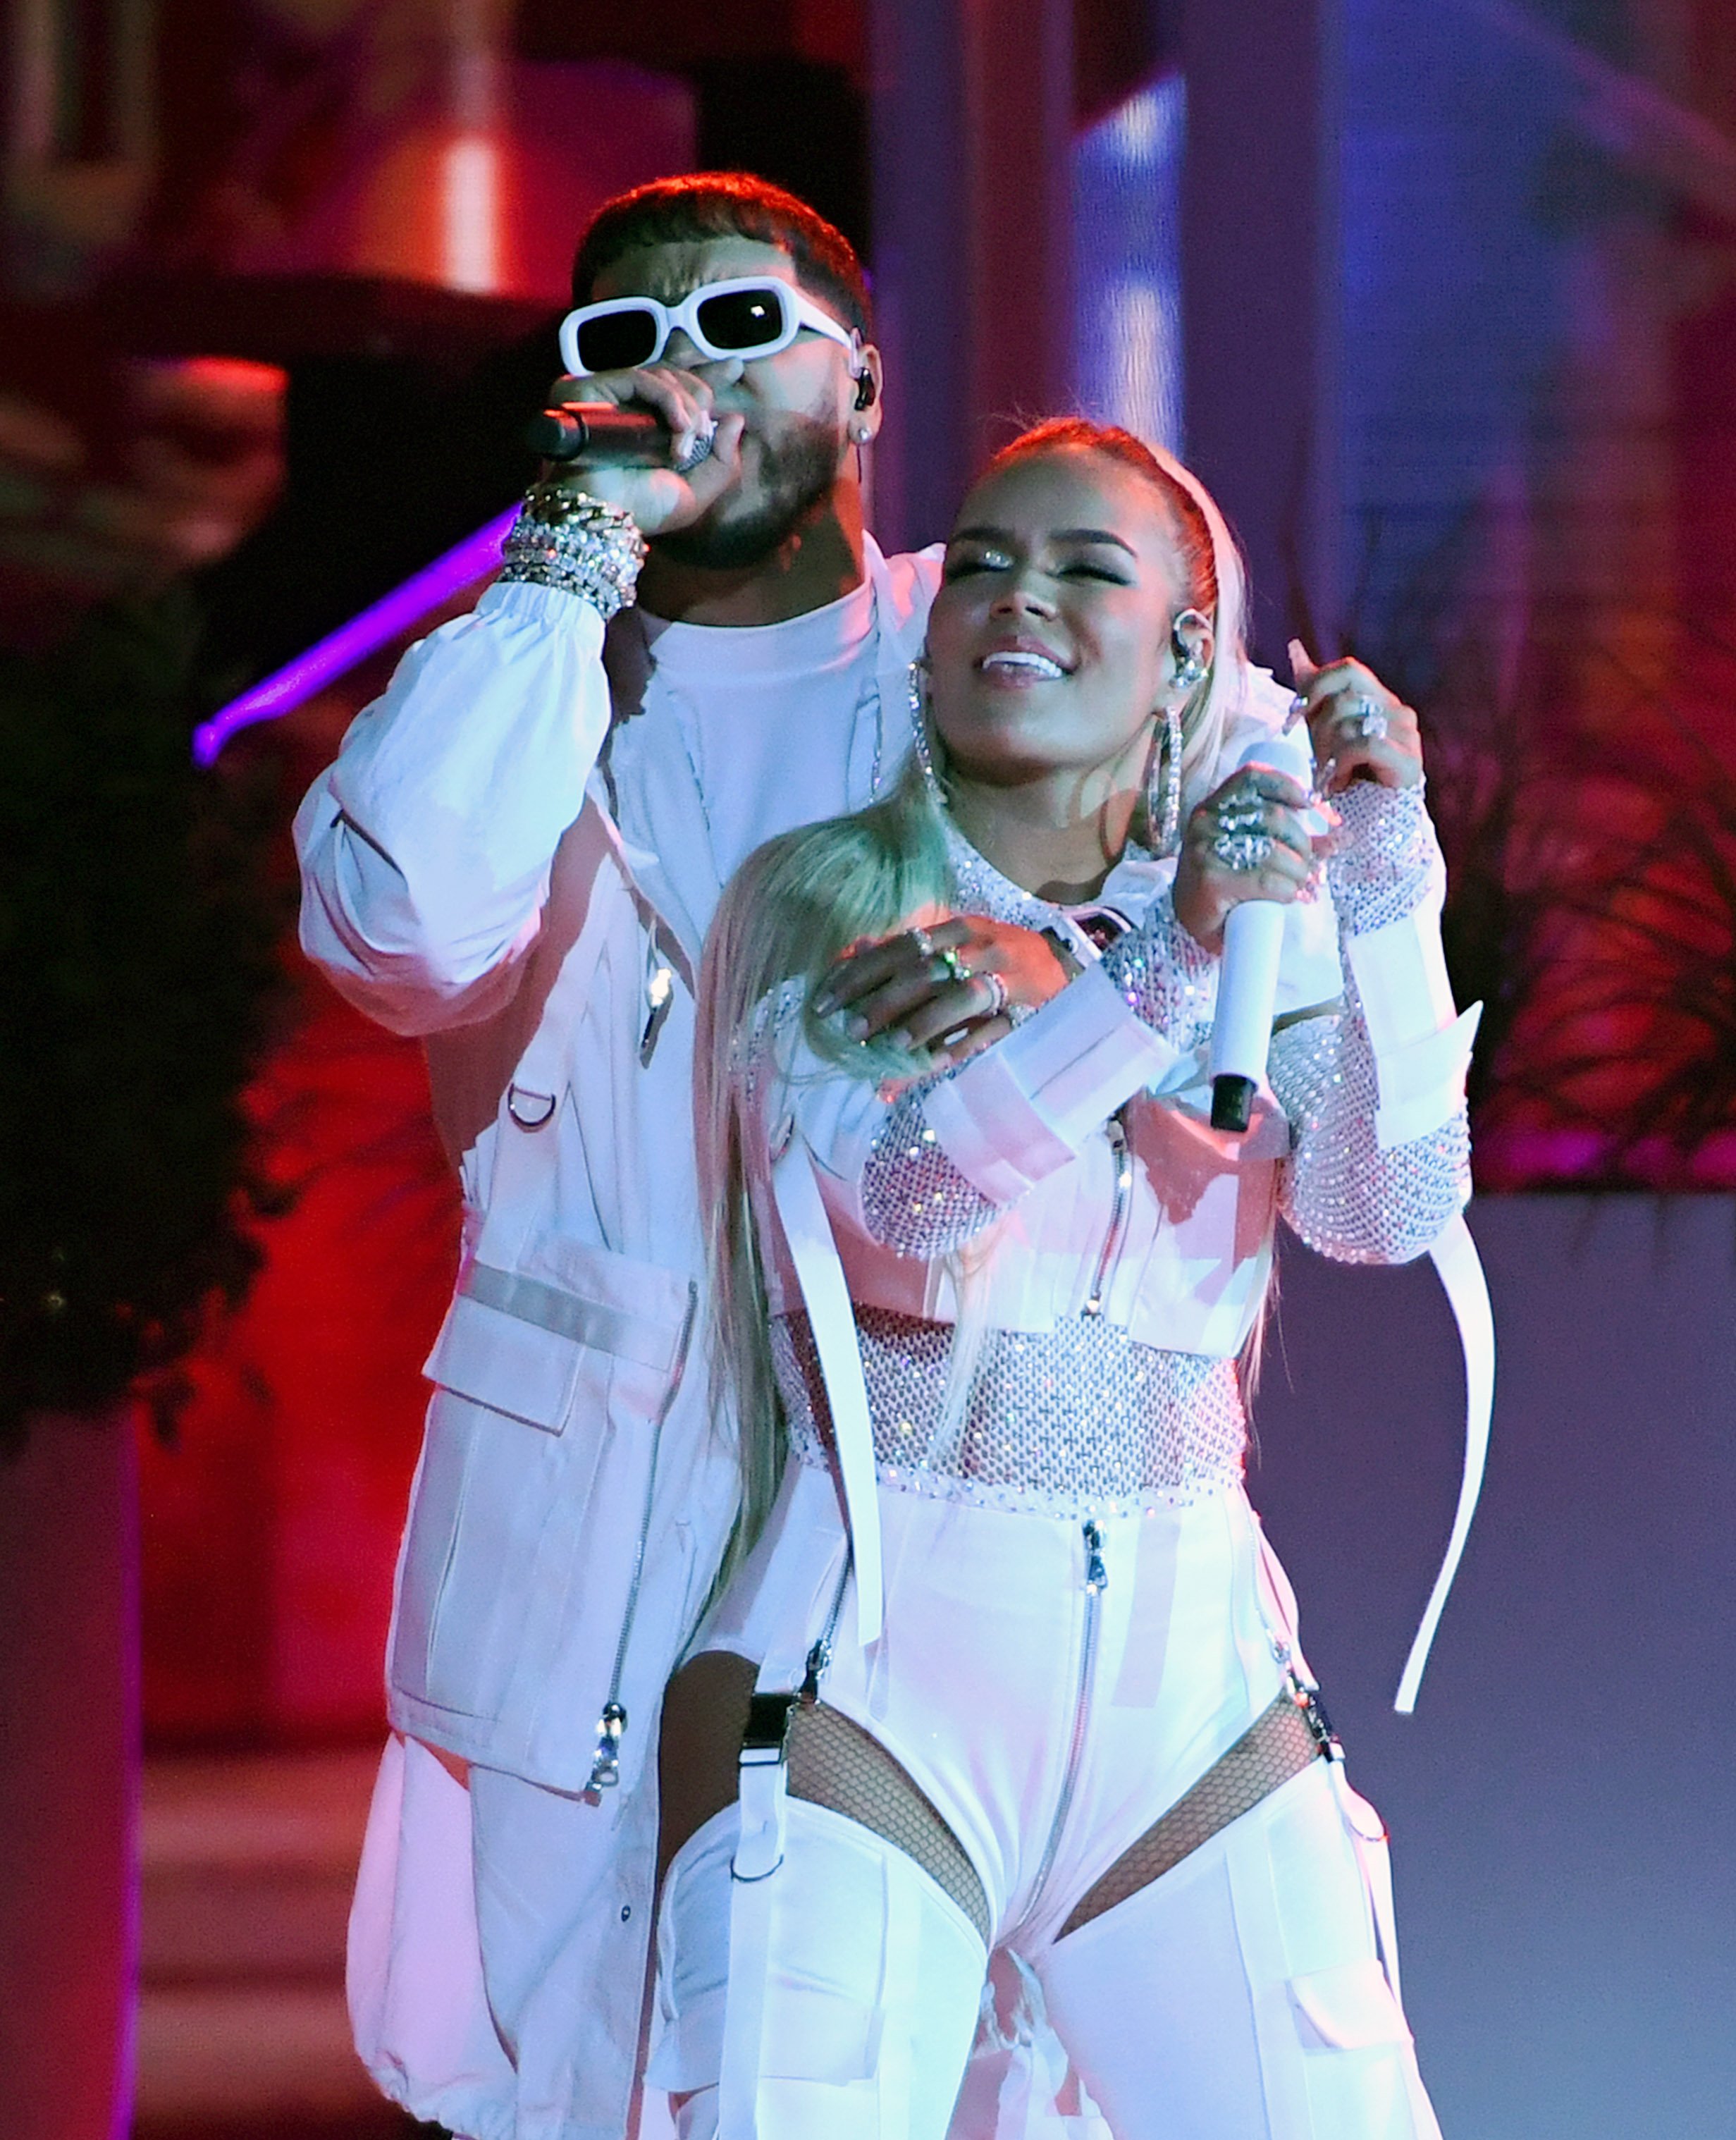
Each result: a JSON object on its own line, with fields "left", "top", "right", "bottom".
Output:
{"left": 651, "top": 1470, "right": 1439, "bottom": 2140}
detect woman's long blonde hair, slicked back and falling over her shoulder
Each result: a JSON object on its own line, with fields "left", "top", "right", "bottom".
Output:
{"left": 694, "top": 417, "right": 1248, "bottom": 1588}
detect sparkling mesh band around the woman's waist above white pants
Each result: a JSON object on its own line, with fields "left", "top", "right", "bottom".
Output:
{"left": 770, "top": 1308, "right": 1248, "bottom": 1515}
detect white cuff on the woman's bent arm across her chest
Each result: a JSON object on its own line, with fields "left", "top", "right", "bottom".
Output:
{"left": 923, "top": 965, "right": 1181, "bottom": 1203}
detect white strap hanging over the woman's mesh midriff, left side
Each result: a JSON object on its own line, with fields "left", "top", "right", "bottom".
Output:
{"left": 770, "top": 1130, "right": 884, "bottom": 1650}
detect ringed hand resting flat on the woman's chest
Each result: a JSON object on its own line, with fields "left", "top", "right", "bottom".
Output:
{"left": 813, "top": 914, "right": 1073, "bottom": 1070}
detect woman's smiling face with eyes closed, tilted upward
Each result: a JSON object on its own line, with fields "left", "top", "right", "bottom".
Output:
{"left": 929, "top": 445, "right": 1209, "bottom": 800}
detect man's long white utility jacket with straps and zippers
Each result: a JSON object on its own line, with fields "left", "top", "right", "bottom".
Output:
{"left": 295, "top": 550, "right": 935, "bottom": 1791}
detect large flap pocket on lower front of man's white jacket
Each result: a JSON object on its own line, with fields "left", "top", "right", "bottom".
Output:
{"left": 392, "top": 1243, "right": 694, "bottom": 1757}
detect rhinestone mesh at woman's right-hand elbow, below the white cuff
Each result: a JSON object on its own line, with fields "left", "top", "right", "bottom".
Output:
{"left": 1267, "top": 973, "right": 1470, "bottom": 1262}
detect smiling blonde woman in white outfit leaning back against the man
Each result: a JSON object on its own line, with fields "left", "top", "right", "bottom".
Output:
{"left": 651, "top": 419, "right": 1472, "bottom": 2140}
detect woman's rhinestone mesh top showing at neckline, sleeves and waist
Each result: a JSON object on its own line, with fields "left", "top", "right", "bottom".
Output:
{"left": 772, "top": 785, "right": 1468, "bottom": 1515}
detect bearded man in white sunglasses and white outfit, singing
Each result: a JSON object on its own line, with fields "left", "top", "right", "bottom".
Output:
{"left": 297, "top": 173, "right": 940, "bottom": 2140}
